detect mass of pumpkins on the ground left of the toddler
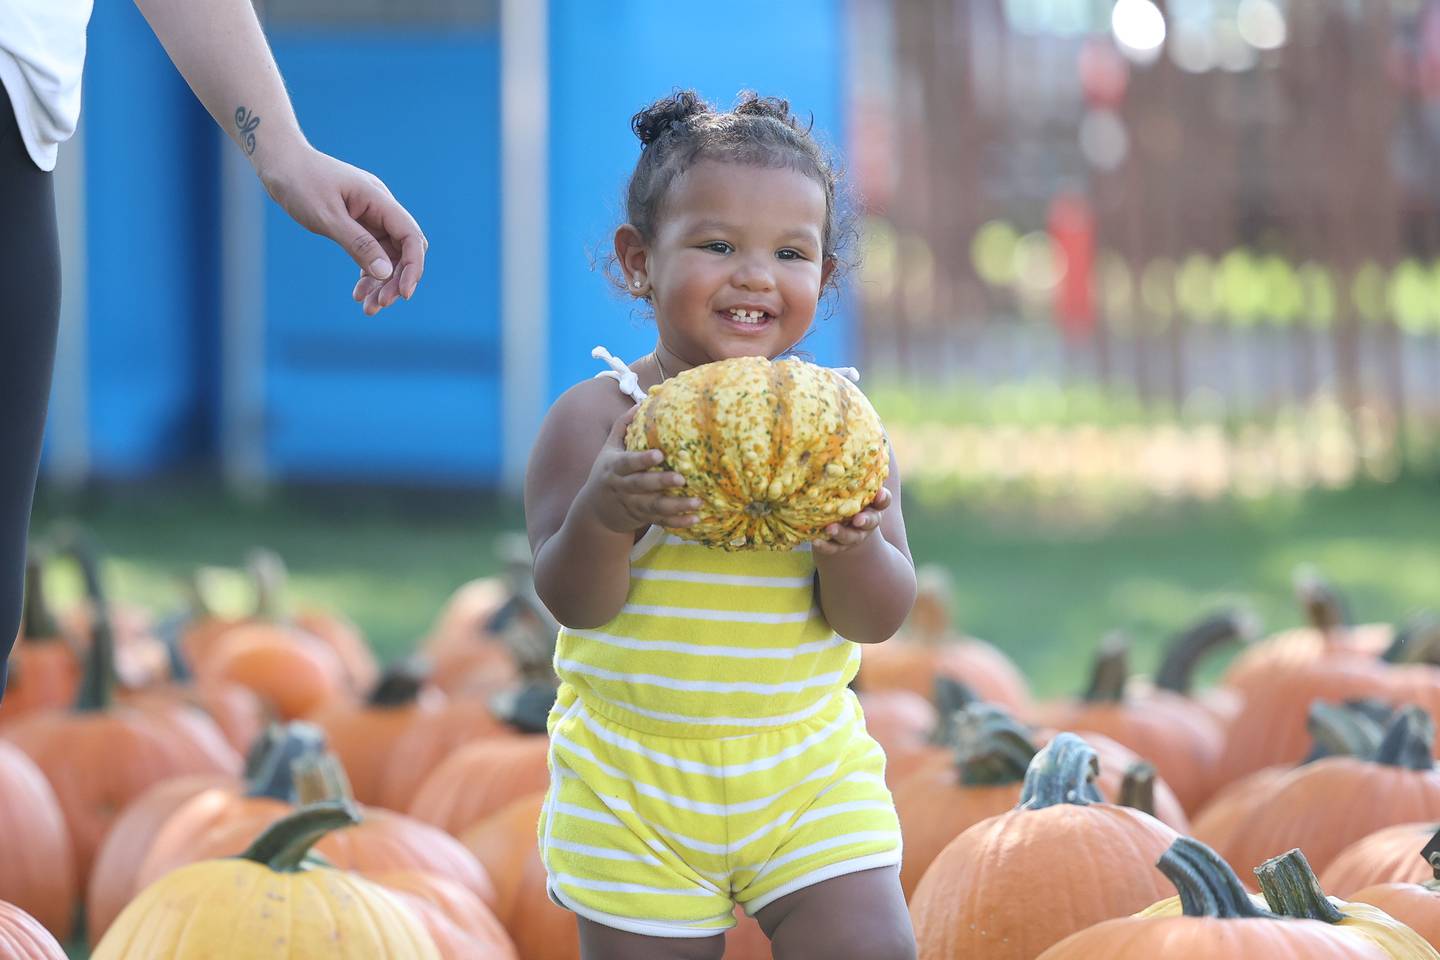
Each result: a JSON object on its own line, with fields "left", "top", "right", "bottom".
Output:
{"left": 0, "top": 533, "right": 601, "bottom": 960}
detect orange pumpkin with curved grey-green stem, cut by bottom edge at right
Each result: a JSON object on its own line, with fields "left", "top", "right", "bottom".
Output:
{"left": 1038, "top": 838, "right": 1390, "bottom": 960}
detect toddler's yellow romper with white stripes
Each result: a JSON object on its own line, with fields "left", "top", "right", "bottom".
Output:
{"left": 539, "top": 352, "right": 900, "bottom": 937}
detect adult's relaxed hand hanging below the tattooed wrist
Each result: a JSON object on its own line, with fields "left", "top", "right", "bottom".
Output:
{"left": 261, "top": 145, "right": 429, "bottom": 317}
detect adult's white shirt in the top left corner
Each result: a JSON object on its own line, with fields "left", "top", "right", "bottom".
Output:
{"left": 0, "top": 0, "right": 94, "bottom": 170}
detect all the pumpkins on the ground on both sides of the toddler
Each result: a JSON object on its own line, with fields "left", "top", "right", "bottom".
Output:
{"left": 0, "top": 521, "right": 1440, "bottom": 960}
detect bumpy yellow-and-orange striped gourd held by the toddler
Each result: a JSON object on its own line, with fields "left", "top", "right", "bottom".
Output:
{"left": 625, "top": 357, "right": 890, "bottom": 550}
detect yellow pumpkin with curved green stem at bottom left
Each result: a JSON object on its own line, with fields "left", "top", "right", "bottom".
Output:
{"left": 92, "top": 803, "right": 441, "bottom": 960}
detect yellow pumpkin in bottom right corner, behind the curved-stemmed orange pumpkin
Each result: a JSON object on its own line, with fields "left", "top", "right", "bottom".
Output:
{"left": 1136, "top": 849, "right": 1440, "bottom": 960}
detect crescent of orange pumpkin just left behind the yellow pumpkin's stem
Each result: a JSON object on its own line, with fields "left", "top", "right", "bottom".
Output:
{"left": 85, "top": 773, "right": 231, "bottom": 948}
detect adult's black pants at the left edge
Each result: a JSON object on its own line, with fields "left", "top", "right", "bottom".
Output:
{"left": 0, "top": 88, "right": 60, "bottom": 695}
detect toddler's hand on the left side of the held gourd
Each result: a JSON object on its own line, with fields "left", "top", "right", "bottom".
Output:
{"left": 585, "top": 407, "right": 700, "bottom": 534}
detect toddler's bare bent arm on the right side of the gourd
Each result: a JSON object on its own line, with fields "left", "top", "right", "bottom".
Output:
{"left": 814, "top": 452, "right": 916, "bottom": 643}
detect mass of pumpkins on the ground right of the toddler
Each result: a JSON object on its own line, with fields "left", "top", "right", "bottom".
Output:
{"left": 860, "top": 571, "right": 1440, "bottom": 960}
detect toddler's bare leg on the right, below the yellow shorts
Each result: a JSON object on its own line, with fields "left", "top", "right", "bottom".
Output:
{"left": 755, "top": 866, "right": 914, "bottom": 960}
